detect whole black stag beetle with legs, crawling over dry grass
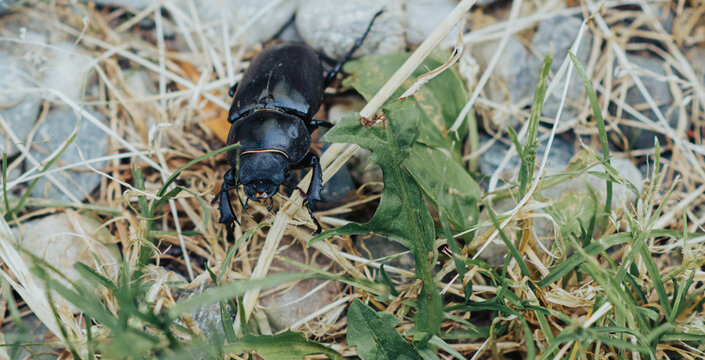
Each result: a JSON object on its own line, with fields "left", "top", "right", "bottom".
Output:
{"left": 214, "top": 10, "right": 383, "bottom": 238}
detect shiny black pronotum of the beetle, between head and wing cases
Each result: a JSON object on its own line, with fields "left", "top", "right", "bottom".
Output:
{"left": 228, "top": 110, "right": 311, "bottom": 165}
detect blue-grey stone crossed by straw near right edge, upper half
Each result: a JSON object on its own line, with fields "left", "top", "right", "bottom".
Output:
{"left": 610, "top": 55, "right": 678, "bottom": 149}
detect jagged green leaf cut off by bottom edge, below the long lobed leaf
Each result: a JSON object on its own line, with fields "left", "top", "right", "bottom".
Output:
{"left": 347, "top": 299, "right": 420, "bottom": 360}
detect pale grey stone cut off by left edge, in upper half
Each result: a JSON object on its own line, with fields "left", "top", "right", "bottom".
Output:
{"left": 0, "top": 53, "right": 41, "bottom": 156}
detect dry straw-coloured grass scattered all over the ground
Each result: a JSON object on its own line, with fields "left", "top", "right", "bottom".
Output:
{"left": 0, "top": 0, "right": 705, "bottom": 359}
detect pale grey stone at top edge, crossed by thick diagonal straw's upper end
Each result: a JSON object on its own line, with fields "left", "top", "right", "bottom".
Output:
{"left": 406, "top": 0, "right": 460, "bottom": 48}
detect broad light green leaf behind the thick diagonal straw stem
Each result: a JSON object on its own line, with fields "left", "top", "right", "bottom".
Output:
{"left": 345, "top": 53, "right": 467, "bottom": 149}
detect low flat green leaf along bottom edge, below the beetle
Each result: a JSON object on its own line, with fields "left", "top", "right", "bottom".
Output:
{"left": 225, "top": 331, "right": 343, "bottom": 360}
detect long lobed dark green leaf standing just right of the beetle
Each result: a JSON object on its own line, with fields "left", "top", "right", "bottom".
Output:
{"left": 309, "top": 99, "right": 443, "bottom": 340}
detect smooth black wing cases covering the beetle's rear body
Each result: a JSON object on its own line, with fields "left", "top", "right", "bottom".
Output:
{"left": 228, "top": 44, "right": 323, "bottom": 123}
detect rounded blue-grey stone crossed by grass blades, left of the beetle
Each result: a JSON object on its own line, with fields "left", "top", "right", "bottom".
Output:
{"left": 30, "top": 109, "right": 107, "bottom": 201}
